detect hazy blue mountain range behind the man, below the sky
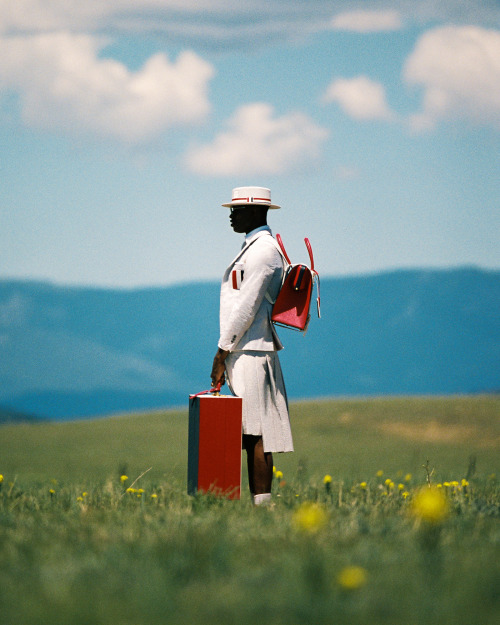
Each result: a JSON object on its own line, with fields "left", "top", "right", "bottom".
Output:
{"left": 0, "top": 268, "right": 500, "bottom": 421}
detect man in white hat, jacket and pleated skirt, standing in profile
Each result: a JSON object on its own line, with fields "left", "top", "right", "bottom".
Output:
{"left": 211, "top": 187, "right": 293, "bottom": 505}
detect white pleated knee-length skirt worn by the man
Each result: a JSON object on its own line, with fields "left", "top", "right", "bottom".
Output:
{"left": 226, "top": 351, "right": 293, "bottom": 453}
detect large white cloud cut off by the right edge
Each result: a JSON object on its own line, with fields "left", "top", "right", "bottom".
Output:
{"left": 404, "top": 26, "right": 500, "bottom": 130}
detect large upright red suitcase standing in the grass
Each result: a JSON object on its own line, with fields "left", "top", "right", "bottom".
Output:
{"left": 188, "top": 391, "right": 242, "bottom": 499}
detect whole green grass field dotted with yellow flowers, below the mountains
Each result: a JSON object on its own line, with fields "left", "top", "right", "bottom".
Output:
{"left": 0, "top": 396, "right": 500, "bottom": 625}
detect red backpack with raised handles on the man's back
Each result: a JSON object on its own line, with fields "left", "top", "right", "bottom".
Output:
{"left": 266, "top": 234, "right": 321, "bottom": 334}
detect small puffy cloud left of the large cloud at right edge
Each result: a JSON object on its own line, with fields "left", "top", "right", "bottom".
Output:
{"left": 323, "top": 76, "right": 394, "bottom": 120}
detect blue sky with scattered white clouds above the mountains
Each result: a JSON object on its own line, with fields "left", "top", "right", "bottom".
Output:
{"left": 0, "top": 0, "right": 500, "bottom": 288}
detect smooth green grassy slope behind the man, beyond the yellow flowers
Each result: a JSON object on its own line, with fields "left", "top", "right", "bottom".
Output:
{"left": 0, "top": 395, "right": 500, "bottom": 490}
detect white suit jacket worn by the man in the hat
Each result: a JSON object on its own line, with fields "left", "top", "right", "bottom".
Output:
{"left": 219, "top": 228, "right": 284, "bottom": 352}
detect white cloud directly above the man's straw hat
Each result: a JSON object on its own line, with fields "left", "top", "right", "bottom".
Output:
{"left": 186, "top": 102, "right": 328, "bottom": 176}
